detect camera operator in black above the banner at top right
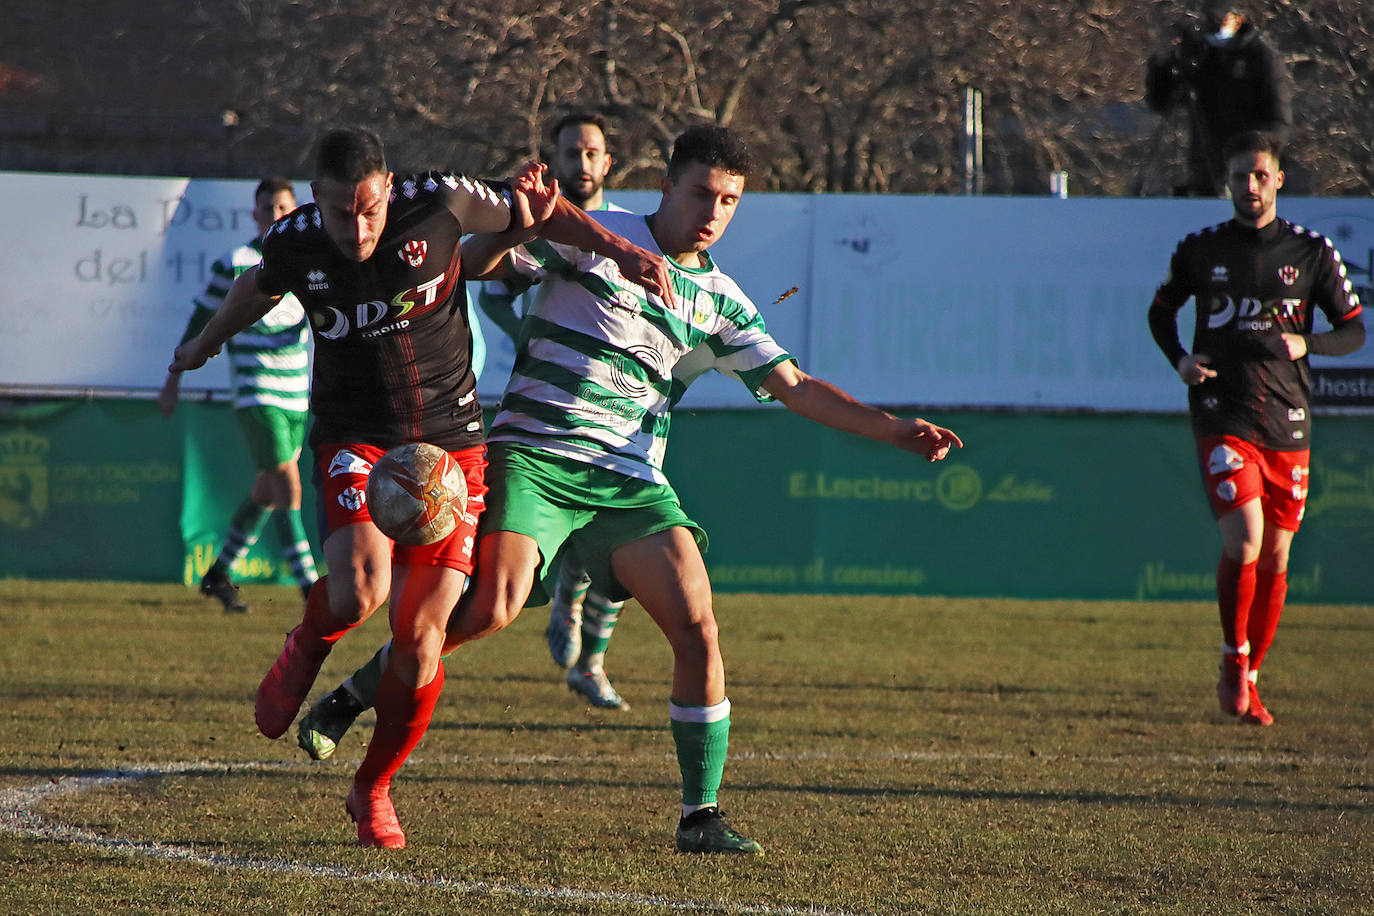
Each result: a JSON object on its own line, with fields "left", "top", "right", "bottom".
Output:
{"left": 1145, "top": 0, "right": 1293, "bottom": 196}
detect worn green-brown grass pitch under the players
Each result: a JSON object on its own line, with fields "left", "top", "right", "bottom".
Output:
{"left": 0, "top": 581, "right": 1374, "bottom": 916}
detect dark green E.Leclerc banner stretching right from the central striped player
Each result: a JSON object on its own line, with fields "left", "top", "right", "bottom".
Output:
{"left": 668, "top": 409, "right": 1374, "bottom": 603}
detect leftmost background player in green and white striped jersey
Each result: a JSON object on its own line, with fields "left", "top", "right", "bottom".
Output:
{"left": 157, "top": 177, "right": 316, "bottom": 612}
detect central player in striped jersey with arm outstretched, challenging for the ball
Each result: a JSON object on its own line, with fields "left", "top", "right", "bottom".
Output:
{"left": 445, "top": 126, "right": 962, "bottom": 854}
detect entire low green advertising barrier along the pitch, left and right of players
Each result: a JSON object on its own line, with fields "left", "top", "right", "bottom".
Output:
{"left": 0, "top": 401, "right": 1374, "bottom": 603}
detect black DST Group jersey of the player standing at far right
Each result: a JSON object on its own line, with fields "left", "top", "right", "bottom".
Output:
{"left": 1150, "top": 220, "right": 1364, "bottom": 450}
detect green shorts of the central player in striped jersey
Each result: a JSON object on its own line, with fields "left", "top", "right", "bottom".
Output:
{"left": 478, "top": 442, "right": 706, "bottom": 607}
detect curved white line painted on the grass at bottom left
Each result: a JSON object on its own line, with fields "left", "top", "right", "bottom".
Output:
{"left": 0, "top": 762, "right": 878, "bottom": 916}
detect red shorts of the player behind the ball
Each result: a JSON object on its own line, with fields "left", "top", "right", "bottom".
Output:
{"left": 315, "top": 442, "right": 486, "bottom": 575}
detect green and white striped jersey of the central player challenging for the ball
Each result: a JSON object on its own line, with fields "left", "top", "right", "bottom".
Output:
{"left": 488, "top": 211, "right": 793, "bottom": 483}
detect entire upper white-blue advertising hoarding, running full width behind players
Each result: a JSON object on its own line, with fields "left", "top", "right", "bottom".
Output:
{"left": 0, "top": 173, "right": 1374, "bottom": 411}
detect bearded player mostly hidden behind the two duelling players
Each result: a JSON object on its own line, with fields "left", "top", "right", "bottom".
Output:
{"left": 478, "top": 111, "right": 629, "bottom": 708}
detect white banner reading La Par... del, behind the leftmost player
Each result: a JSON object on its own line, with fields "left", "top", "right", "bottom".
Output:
{"left": 0, "top": 173, "right": 311, "bottom": 389}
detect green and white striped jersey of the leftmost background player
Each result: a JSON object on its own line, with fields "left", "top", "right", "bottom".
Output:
{"left": 183, "top": 239, "right": 311, "bottom": 413}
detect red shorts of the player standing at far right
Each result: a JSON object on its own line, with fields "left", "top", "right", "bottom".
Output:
{"left": 1198, "top": 435, "right": 1311, "bottom": 531}
